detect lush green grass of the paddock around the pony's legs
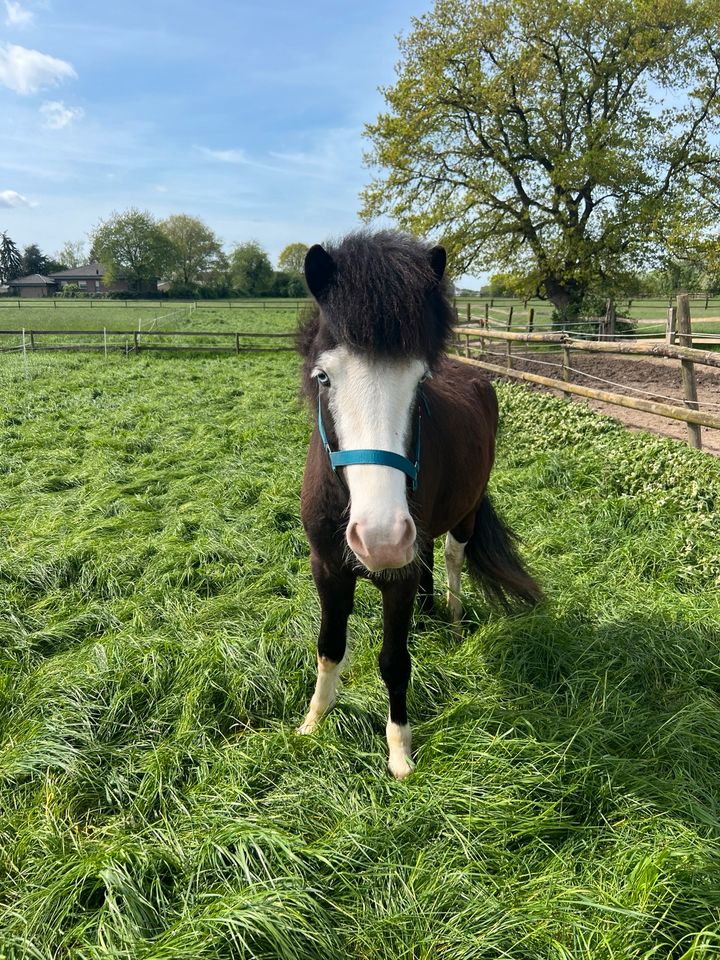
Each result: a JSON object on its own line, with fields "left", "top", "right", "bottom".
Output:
{"left": 0, "top": 336, "right": 720, "bottom": 960}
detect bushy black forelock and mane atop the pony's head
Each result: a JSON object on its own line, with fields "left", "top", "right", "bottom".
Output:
{"left": 297, "top": 230, "right": 455, "bottom": 384}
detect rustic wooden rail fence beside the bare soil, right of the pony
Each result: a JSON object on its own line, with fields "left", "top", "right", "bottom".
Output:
{"left": 456, "top": 295, "right": 720, "bottom": 449}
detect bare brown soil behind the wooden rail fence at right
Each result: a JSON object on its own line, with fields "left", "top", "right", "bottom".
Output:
{"left": 486, "top": 352, "right": 720, "bottom": 456}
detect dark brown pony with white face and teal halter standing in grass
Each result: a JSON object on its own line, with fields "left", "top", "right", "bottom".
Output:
{"left": 297, "top": 231, "right": 541, "bottom": 779}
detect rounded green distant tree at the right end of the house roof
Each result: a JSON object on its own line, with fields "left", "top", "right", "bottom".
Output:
{"left": 92, "top": 213, "right": 177, "bottom": 290}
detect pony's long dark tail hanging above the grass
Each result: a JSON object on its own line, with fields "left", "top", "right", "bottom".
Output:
{"left": 465, "top": 494, "right": 543, "bottom": 610}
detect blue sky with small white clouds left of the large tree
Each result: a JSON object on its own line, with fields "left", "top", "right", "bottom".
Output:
{"left": 0, "top": 0, "right": 478, "bottom": 282}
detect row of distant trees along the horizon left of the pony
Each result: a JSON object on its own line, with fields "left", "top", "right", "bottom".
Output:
{"left": 0, "top": 207, "right": 307, "bottom": 298}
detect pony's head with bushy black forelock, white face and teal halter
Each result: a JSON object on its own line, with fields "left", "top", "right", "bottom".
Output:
{"left": 300, "top": 231, "right": 454, "bottom": 572}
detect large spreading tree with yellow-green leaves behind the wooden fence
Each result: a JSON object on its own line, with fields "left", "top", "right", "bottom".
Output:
{"left": 362, "top": 0, "right": 720, "bottom": 312}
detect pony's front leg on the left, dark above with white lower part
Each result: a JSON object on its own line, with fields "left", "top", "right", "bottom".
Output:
{"left": 298, "top": 558, "right": 356, "bottom": 733}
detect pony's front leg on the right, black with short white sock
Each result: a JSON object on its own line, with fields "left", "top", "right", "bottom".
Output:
{"left": 378, "top": 579, "right": 417, "bottom": 780}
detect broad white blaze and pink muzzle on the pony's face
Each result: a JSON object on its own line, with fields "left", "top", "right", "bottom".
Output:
{"left": 316, "top": 346, "right": 426, "bottom": 570}
